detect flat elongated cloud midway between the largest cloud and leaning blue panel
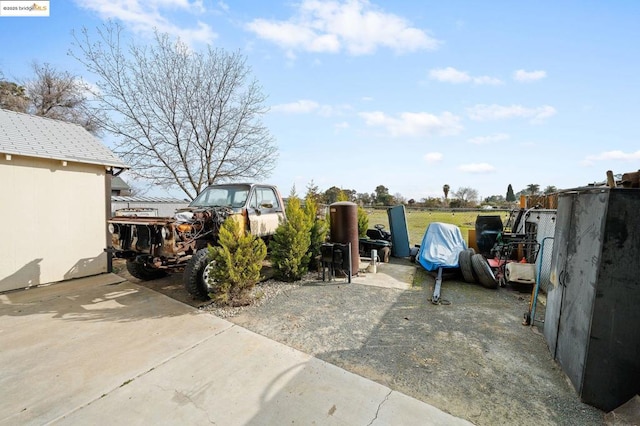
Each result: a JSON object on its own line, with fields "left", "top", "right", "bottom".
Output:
{"left": 359, "top": 111, "right": 462, "bottom": 137}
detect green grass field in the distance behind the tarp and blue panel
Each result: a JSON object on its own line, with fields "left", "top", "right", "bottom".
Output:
{"left": 367, "top": 209, "right": 509, "bottom": 247}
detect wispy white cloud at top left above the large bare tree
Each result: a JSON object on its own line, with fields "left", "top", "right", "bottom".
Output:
{"left": 77, "top": 0, "right": 217, "bottom": 44}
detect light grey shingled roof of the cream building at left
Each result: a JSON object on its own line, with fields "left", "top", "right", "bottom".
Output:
{"left": 0, "top": 109, "right": 128, "bottom": 168}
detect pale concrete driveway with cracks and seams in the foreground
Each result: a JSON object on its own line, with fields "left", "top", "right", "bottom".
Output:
{"left": 0, "top": 274, "right": 470, "bottom": 425}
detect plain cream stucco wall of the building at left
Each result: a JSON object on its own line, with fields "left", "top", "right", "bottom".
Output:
{"left": 0, "top": 155, "right": 107, "bottom": 291}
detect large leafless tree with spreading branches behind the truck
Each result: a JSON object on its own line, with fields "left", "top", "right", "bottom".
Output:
{"left": 70, "top": 23, "right": 277, "bottom": 199}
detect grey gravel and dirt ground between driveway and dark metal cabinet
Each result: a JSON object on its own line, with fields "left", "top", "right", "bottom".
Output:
{"left": 116, "top": 259, "right": 604, "bottom": 426}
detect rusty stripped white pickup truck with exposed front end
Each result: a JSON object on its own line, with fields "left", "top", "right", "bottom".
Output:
{"left": 106, "top": 183, "right": 285, "bottom": 299}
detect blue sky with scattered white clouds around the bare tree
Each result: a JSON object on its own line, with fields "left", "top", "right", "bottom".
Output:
{"left": 0, "top": 0, "right": 640, "bottom": 201}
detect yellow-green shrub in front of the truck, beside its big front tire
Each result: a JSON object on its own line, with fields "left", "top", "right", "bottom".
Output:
{"left": 209, "top": 217, "right": 267, "bottom": 306}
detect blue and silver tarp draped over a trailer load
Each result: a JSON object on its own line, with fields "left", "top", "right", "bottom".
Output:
{"left": 417, "top": 222, "right": 467, "bottom": 271}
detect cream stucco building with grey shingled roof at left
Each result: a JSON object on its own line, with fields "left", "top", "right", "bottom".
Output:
{"left": 0, "top": 109, "right": 127, "bottom": 291}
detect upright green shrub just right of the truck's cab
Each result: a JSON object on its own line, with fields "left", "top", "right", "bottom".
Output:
{"left": 269, "top": 196, "right": 313, "bottom": 281}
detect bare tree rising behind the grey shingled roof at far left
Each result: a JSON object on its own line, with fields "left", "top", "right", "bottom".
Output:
{"left": 24, "top": 62, "right": 98, "bottom": 133}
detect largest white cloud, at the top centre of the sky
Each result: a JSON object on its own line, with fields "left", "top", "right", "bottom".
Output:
{"left": 246, "top": 0, "right": 439, "bottom": 55}
